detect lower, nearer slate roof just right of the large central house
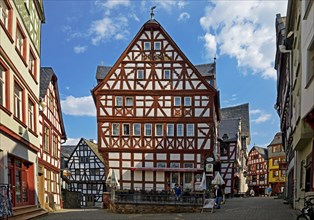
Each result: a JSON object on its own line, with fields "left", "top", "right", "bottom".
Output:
{"left": 218, "top": 118, "right": 241, "bottom": 141}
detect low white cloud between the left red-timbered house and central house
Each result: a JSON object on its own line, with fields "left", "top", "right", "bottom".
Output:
{"left": 61, "top": 96, "right": 96, "bottom": 116}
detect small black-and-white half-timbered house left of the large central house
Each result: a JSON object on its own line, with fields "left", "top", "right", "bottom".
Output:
{"left": 67, "top": 138, "right": 106, "bottom": 206}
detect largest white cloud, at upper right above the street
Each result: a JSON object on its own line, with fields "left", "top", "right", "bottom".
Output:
{"left": 200, "top": 0, "right": 287, "bottom": 79}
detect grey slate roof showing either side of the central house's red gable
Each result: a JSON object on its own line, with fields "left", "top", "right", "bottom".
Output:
{"left": 96, "top": 63, "right": 216, "bottom": 83}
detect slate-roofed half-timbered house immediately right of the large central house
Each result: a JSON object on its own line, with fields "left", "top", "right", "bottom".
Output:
{"left": 218, "top": 104, "right": 250, "bottom": 196}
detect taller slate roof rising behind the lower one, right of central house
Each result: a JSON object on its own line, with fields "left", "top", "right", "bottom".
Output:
{"left": 220, "top": 103, "right": 250, "bottom": 138}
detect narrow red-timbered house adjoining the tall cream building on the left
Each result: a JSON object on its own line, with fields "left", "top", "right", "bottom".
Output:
{"left": 37, "top": 67, "right": 66, "bottom": 209}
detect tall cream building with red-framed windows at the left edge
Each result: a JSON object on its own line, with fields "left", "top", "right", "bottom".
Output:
{"left": 0, "top": 0, "right": 45, "bottom": 207}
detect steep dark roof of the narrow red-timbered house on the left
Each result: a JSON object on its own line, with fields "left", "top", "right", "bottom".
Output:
{"left": 39, "top": 67, "right": 67, "bottom": 140}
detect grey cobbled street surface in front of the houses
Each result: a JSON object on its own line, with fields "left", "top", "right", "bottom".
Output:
{"left": 39, "top": 197, "right": 300, "bottom": 220}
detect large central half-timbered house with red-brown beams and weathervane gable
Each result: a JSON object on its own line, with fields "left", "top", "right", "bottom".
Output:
{"left": 92, "top": 19, "right": 220, "bottom": 190}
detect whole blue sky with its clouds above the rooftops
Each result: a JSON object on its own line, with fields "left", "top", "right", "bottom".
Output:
{"left": 41, "top": 0, "right": 287, "bottom": 150}
